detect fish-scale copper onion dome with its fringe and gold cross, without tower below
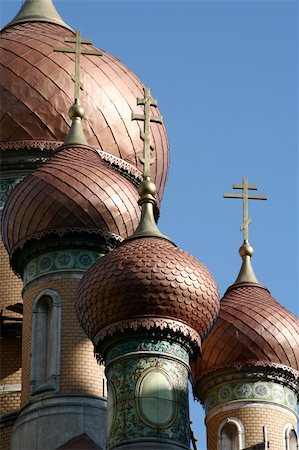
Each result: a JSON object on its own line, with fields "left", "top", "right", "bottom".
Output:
{"left": 75, "top": 88, "right": 219, "bottom": 356}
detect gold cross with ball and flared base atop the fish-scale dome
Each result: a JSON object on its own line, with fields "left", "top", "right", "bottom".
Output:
{"left": 127, "top": 88, "right": 170, "bottom": 241}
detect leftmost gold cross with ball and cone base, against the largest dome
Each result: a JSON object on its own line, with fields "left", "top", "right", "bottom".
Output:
{"left": 54, "top": 31, "right": 102, "bottom": 145}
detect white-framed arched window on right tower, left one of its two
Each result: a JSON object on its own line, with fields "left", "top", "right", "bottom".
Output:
{"left": 218, "top": 417, "right": 245, "bottom": 450}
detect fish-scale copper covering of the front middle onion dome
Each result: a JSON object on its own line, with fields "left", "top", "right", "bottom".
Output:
{"left": 76, "top": 238, "right": 219, "bottom": 343}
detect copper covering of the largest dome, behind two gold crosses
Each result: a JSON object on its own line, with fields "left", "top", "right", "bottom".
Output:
{"left": 0, "top": 22, "right": 169, "bottom": 198}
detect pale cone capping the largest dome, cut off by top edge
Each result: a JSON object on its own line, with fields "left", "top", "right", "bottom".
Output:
{"left": 4, "top": 0, "right": 72, "bottom": 30}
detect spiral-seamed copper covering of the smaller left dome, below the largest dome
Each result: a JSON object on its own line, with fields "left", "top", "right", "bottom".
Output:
{"left": 2, "top": 146, "right": 140, "bottom": 252}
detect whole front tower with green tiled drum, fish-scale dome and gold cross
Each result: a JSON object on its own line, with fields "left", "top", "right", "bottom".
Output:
{"left": 76, "top": 88, "right": 219, "bottom": 450}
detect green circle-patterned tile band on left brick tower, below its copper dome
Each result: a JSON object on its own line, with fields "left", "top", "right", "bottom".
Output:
{"left": 23, "top": 250, "right": 103, "bottom": 285}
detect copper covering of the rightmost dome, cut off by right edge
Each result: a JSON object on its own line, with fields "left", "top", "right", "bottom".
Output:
{"left": 193, "top": 282, "right": 299, "bottom": 379}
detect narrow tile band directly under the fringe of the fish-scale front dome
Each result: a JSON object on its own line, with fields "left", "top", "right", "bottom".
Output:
{"left": 105, "top": 338, "right": 189, "bottom": 365}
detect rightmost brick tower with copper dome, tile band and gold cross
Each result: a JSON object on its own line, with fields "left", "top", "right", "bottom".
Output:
{"left": 193, "top": 178, "right": 299, "bottom": 450}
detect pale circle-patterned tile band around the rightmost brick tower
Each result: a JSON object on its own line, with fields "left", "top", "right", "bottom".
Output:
{"left": 205, "top": 381, "right": 297, "bottom": 412}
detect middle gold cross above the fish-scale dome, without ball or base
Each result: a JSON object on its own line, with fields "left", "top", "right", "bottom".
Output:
{"left": 132, "top": 87, "right": 163, "bottom": 178}
